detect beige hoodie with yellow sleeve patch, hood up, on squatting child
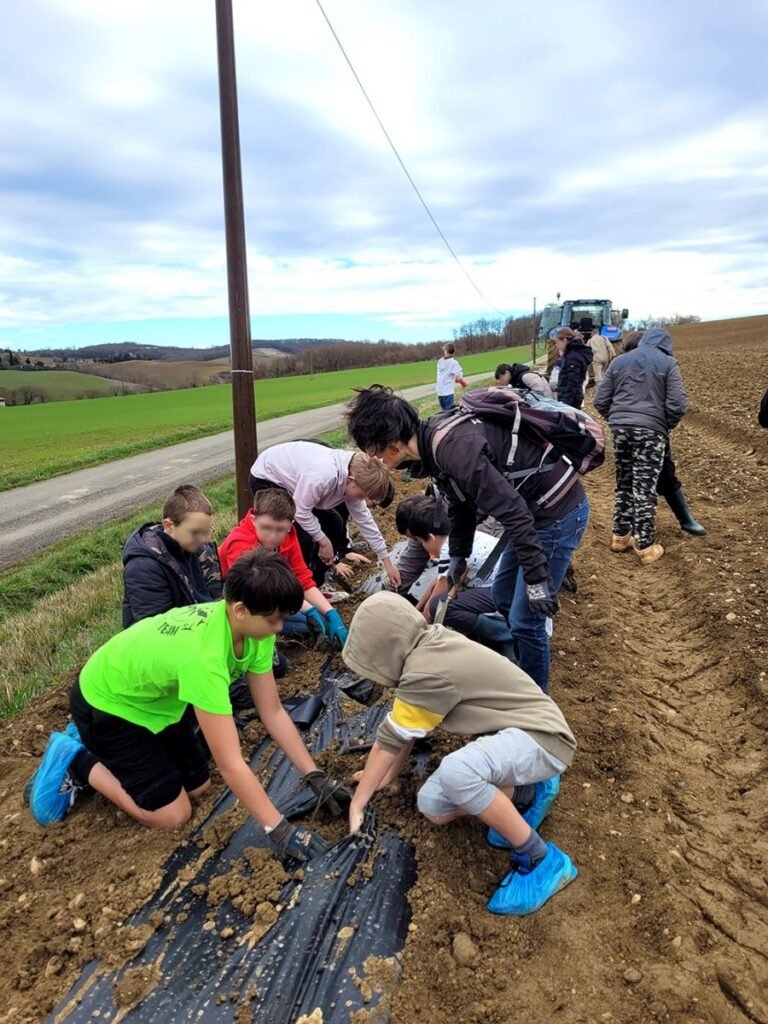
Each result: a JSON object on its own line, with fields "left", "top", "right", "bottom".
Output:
{"left": 342, "top": 592, "right": 577, "bottom": 765}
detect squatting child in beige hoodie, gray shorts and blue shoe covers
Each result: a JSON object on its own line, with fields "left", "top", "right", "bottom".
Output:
{"left": 342, "top": 593, "right": 577, "bottom": 914}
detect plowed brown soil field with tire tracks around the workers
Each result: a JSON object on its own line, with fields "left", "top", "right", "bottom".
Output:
{"left": 0, "top": 319, "right": 768, "bottom": 1024}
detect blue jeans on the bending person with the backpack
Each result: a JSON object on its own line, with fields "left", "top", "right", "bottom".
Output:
{"left": 494, "top": 497, "right": 590, "bottom": 693}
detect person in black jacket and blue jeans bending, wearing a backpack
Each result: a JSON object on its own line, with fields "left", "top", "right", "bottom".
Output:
{"left": 347, "top": 384, "right": 589, "bottom": 692}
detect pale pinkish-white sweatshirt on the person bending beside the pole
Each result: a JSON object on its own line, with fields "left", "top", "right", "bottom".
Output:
{"left": 251, "top": 441, "right": 387, "bottom": 558}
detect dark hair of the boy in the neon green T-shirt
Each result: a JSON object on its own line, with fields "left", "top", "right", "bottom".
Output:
{"left": 224, "top": 548, "right": 304, "bottom": 615}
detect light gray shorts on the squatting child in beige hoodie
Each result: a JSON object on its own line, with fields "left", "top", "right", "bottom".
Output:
{"left": 417, "top": 728, "right": 566, "bottom": 818}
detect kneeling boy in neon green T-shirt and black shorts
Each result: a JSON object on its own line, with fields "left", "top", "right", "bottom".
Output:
{"left": 25, "top": 551, "right": 351, "bottom": 860}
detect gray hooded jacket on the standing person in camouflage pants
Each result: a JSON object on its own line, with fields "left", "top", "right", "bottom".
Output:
{"left": 595, "top": 329, "right": 688, "bottom": 434}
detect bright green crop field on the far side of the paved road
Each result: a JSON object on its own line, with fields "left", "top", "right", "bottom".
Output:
{"left": 0, "top": 347, "right": 529, "bottom": 490}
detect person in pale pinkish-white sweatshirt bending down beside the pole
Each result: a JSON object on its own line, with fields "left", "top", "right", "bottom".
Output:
{"left": 250, "top": 441, "right": 400, "bottom": 587}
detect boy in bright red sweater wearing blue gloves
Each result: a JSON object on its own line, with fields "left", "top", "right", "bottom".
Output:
{"left": 219, "top": 487, "right": 347, "bottom": 647}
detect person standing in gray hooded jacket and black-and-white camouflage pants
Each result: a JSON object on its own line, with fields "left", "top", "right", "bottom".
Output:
{"left": 595, "top": 328, "right": 688, "bottom": 565}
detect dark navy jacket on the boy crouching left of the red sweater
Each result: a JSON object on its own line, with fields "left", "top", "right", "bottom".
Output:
{"left": 123, "top": 522, "right": 222, "bottom": 629}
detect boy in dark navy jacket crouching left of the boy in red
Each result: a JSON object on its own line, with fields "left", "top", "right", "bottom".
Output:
{"left": 123, "top": 483, "right": 222, "bottom": 629}
